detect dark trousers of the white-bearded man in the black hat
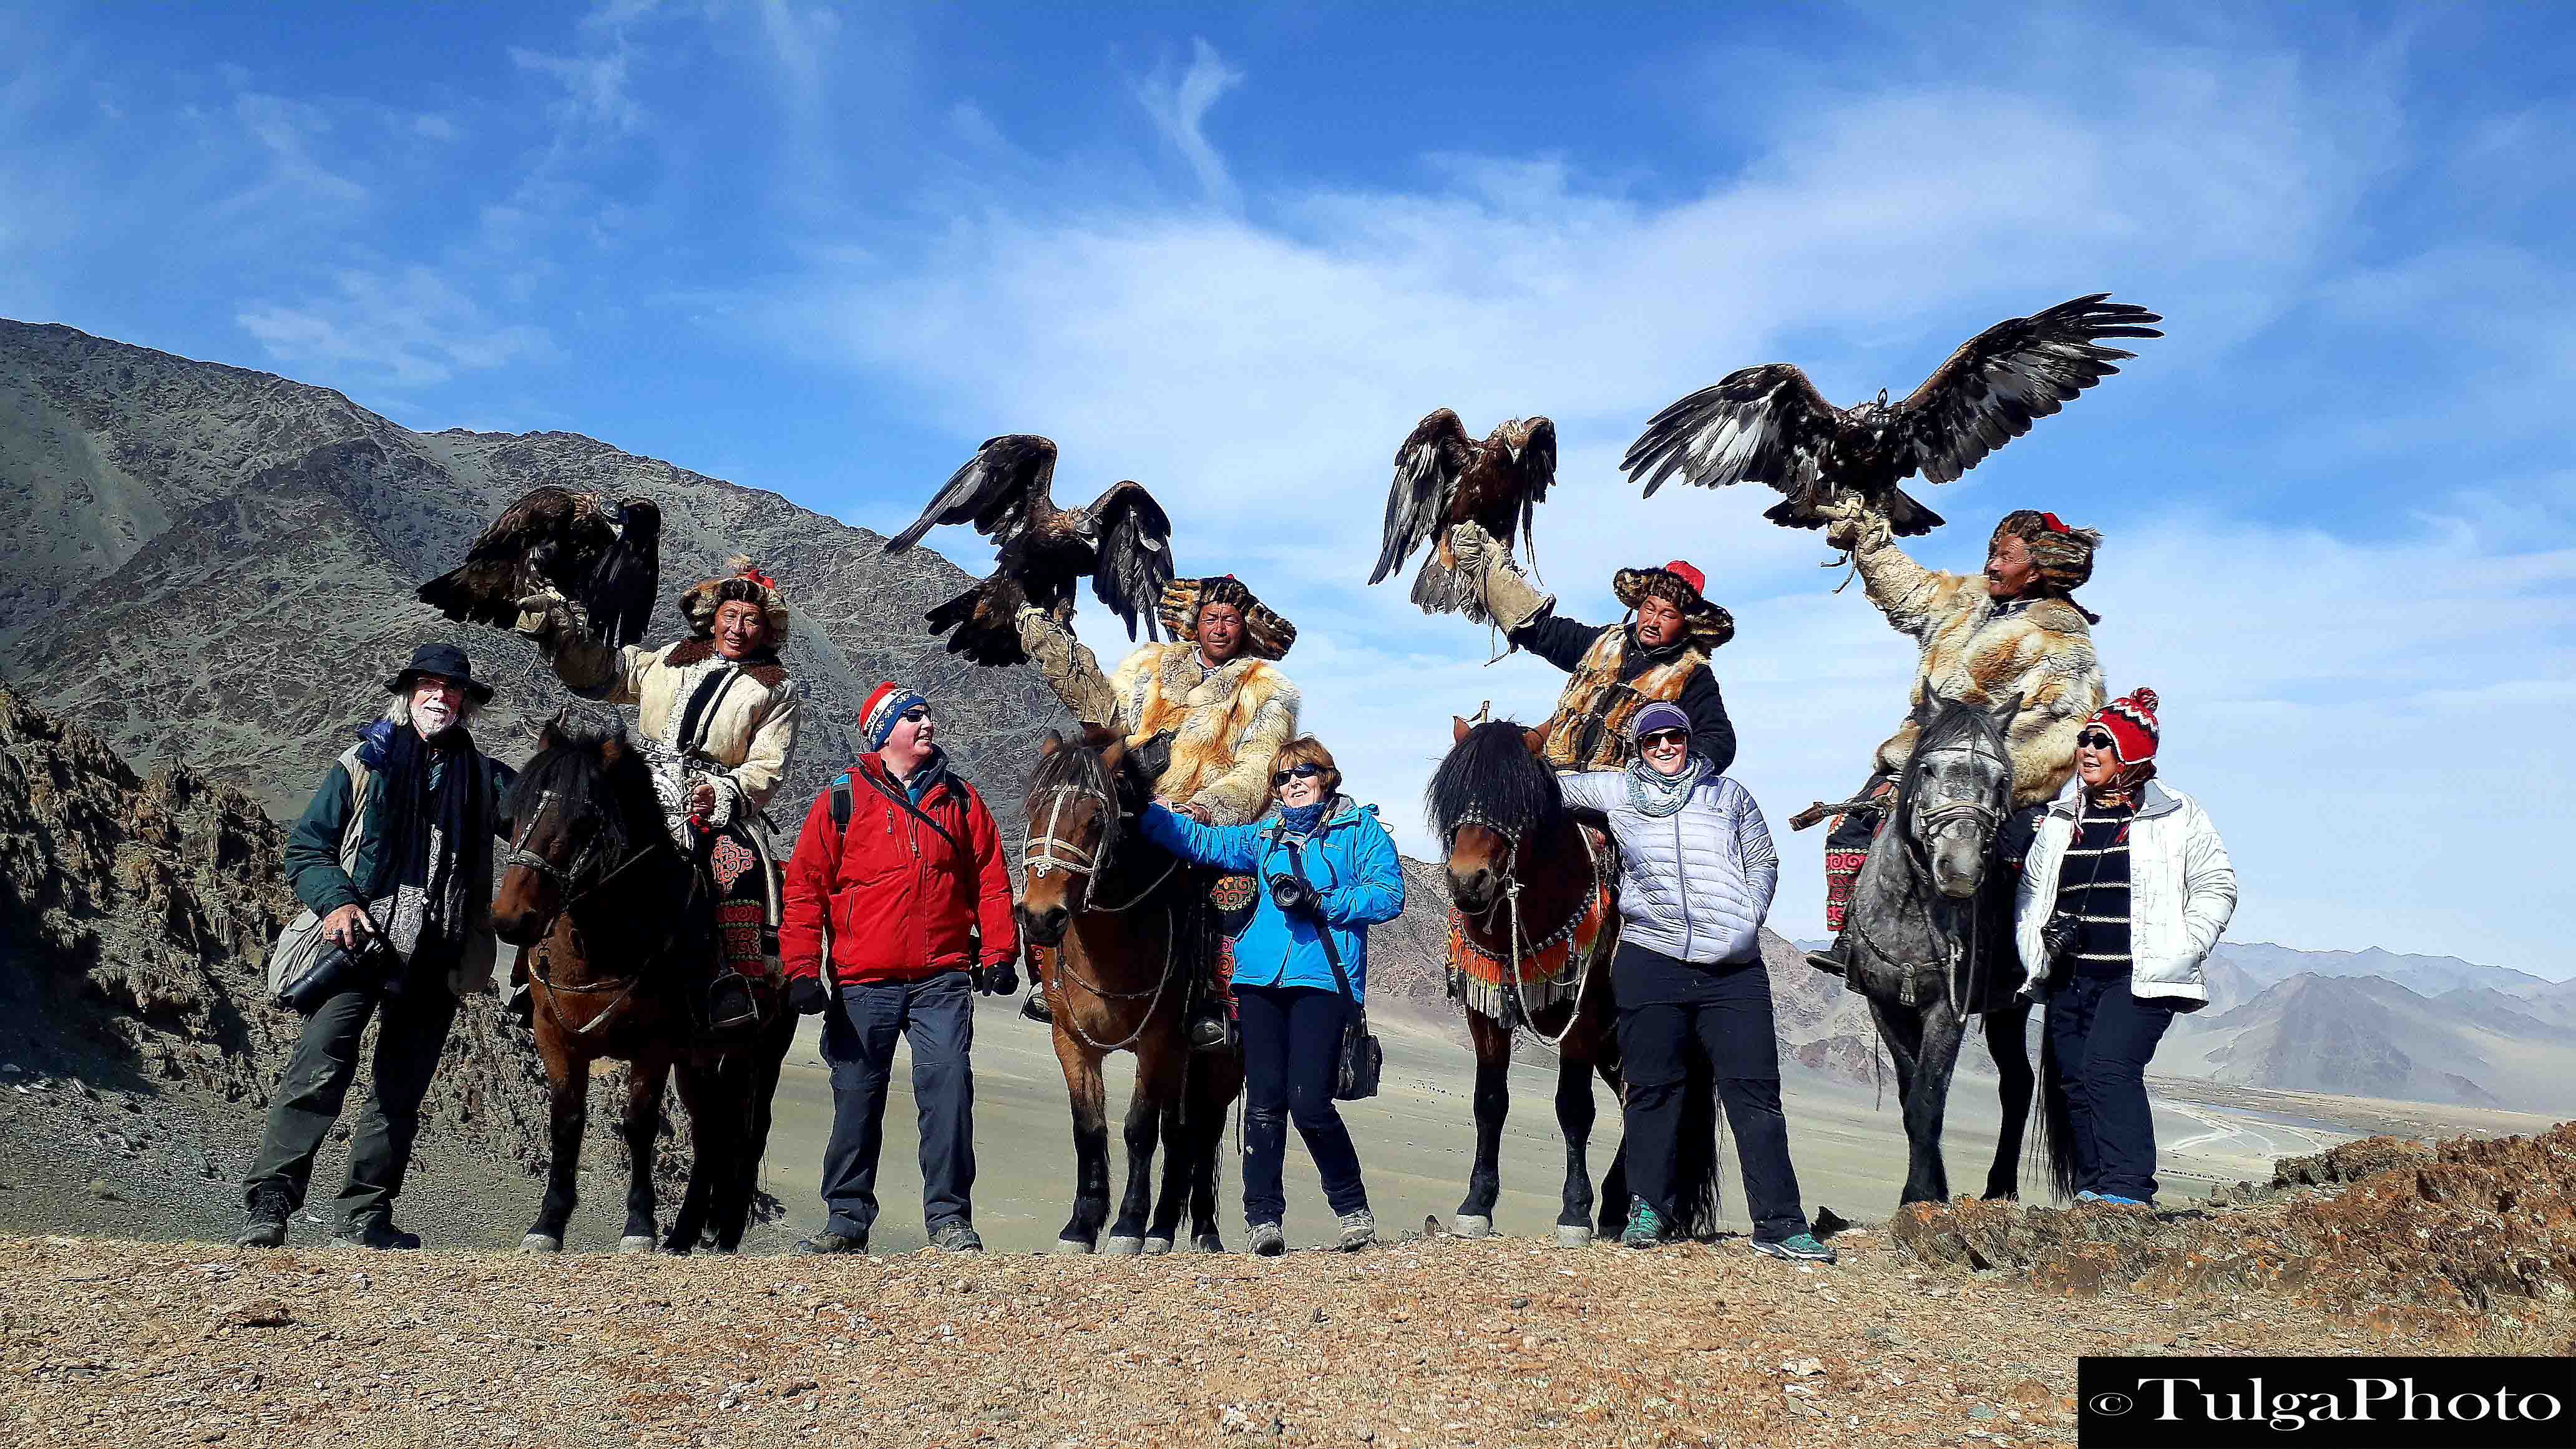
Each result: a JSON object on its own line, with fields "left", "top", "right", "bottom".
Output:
{"left": 242, "top": 980, "right": 456, "bottom": 1227}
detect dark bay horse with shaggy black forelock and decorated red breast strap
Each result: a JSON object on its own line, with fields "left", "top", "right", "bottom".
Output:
{"left": 1425, "top": 717, "right": 1718, "bottom": 1248}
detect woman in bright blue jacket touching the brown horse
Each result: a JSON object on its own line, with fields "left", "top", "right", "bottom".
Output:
{"left": 1144, "top": 735, "right": 1404, "bottom": 1258}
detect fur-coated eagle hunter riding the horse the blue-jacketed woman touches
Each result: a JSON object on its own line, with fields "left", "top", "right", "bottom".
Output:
{"left": 1018, "top": 575, "right": 1299, "bottom": 1050}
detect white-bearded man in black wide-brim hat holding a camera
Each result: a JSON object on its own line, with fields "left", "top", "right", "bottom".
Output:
{"left": 235, "top": 645, "right": 512, "bottom": 1248}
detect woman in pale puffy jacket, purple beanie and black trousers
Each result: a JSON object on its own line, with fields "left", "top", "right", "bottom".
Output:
{"left": 1564, "top": 701, "right": 1834, "bottom": 1264}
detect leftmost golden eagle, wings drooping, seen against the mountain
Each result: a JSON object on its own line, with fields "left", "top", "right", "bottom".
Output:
{"left": 420, "top": 485, "right": 662, "bottom": 650}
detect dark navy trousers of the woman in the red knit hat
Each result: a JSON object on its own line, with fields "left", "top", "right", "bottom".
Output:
{"left": 2048, "top": 972, "right": 2174, "bottom": 1201}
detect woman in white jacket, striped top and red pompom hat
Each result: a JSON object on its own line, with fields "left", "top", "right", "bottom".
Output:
{"left": 2014, "top": 688, "right": 2236, "bottom": 1207}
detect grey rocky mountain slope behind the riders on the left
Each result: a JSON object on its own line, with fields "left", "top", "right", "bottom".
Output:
{"left": 0, "top": 322, "right": 1066, "bottom": 833}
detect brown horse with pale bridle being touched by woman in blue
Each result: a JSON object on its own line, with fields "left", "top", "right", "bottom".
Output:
{"left": 1020, "top": 724, "right": 1244, "bottom": 1256}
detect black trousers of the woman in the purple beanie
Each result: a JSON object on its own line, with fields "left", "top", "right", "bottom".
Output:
{"left": 1612, "top": 946, "right": 1808, "bottom": 1242}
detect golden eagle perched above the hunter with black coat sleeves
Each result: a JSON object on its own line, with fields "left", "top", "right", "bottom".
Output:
{"left": 1368, "top": 407, "right": 1556, "bottom": 619}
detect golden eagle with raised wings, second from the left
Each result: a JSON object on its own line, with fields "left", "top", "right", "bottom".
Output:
{"left": 886, "top": 433, "right": 1172, "bottom": 665}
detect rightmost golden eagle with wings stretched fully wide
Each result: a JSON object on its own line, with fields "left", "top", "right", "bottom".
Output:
{"left": 1621, "top": 291, "right": 2164, "bottom": 536}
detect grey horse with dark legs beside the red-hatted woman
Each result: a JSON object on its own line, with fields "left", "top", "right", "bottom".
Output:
{"left": 1845, "top": 693, "right": 2074, "bottom": 1207}
